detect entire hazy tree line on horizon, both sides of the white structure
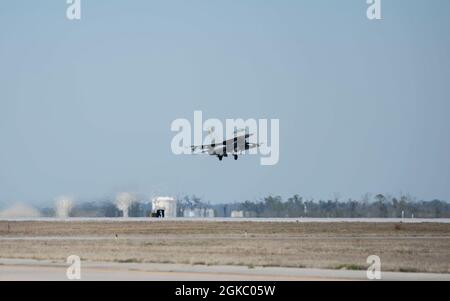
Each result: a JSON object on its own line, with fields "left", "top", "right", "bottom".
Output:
{"left": 41, "top": 194, "right": 450, "bottom": 218}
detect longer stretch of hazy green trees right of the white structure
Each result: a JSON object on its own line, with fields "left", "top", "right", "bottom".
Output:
{"left": 171, "top": 194, "right": 450, "bottom": 218}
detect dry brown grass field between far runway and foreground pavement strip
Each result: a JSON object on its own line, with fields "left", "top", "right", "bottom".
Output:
{"left": 0, "top": 220, "right": 450, "bottom": 273}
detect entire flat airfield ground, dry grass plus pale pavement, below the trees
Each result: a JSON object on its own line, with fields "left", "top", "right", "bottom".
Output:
{"left": 0, "top": 219, "right": 450, "bottom": 280}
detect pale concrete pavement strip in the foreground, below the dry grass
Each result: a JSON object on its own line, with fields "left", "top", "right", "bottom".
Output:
{"left": 0, "top": 259, "right": 450, "bottom": 281}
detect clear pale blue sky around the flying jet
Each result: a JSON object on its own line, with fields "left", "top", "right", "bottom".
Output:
{"left": 0, "top": 0, "right": 450, "bottom": 204}
